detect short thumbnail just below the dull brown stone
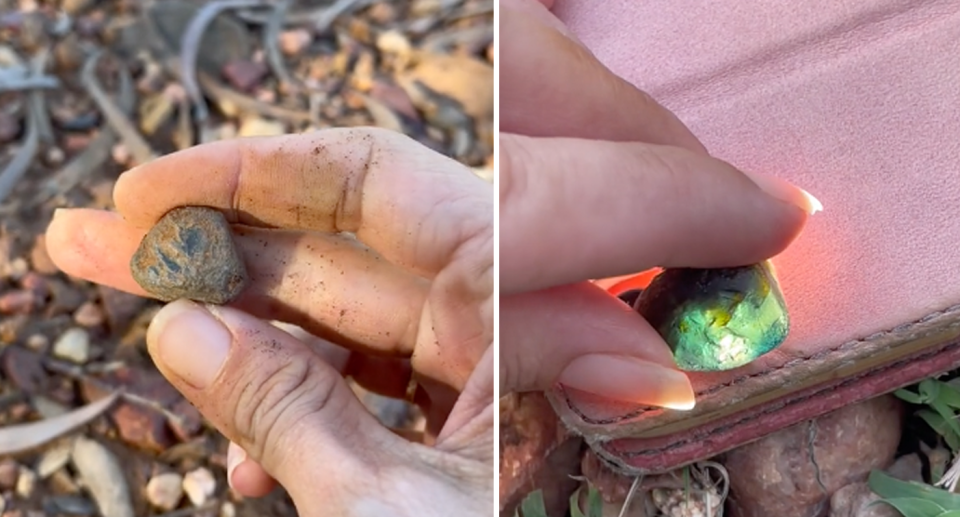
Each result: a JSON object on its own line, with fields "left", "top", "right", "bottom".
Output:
{"left": 147, "top": 300, "right": 232, "bottom": 389}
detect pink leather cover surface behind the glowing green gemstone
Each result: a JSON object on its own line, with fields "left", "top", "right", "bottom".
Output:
{"left": 555, "top": 0, "right": 960, "bottom": 472}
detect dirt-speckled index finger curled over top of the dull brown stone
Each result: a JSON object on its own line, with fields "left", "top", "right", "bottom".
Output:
{"left": 114, "top": 128, "right": 493, "bottom": 276}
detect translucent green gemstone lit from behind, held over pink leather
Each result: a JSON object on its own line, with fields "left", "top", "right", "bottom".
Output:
{"left": 633, "top": 262, "right": 790, "bottom": 371}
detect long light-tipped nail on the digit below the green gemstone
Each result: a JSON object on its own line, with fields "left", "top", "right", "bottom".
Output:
{"left": 558, "top": 354, "right": 696, "bottom": 410}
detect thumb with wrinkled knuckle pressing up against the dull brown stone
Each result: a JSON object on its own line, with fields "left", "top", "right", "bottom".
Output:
{"left": 147, "top": 300, "right": 402, "bottom": 500}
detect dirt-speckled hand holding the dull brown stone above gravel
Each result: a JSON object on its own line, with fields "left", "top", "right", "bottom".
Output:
{"left": 47, "top": 129, "right": 494, "bottom": 516}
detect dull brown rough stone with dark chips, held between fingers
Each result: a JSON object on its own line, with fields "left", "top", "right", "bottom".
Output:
{"left": 130, "top": 207, "right": 248, "bottom": 305}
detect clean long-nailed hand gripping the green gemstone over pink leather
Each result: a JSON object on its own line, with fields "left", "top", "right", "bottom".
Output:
{"left": 499, "top": 0, "right": 818, "bottom": 408}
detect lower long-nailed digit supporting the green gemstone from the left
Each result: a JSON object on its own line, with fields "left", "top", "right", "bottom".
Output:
{"left": 500, "top": 282, "right": 695, "bottom": 409}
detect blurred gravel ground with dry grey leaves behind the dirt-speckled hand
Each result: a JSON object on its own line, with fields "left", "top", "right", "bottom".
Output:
{"left": 0, "top": 0, "right": 494, "bottom": 517}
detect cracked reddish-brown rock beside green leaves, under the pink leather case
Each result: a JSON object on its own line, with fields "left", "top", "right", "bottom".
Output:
{"left": 723, "top": 396, "right": 902, "bottom": 517}
